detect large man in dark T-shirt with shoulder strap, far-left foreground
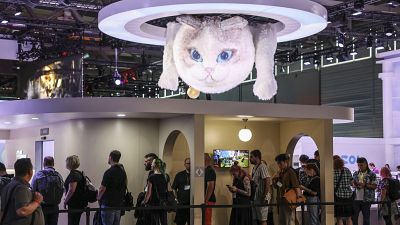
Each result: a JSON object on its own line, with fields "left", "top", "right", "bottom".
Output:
{"left": 1, "top": 158, "right": 44, "bottom": 225}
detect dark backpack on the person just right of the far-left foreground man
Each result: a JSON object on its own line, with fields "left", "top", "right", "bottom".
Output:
{"left": 36, "top": 170, "right": 64, "bottom": 205}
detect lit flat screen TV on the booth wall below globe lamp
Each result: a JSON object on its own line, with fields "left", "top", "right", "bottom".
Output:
{"left": 213, "top": 149, "right": 249, "bottom": 168}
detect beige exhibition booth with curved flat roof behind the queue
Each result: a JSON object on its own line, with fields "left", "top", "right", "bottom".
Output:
{"left": 0, "top": 98, "right": 353, "bottom": 225}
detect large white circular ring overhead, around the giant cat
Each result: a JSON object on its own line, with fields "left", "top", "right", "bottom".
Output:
{"left": 98, "top": 0, "right": 327, "bottom": 45}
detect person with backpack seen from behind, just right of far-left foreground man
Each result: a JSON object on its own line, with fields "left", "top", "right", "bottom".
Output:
{"left": 32, "top": 156, "right": 64, "bottom": 225}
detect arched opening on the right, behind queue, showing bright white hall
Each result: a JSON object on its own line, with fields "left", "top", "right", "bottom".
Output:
{"left": 286, "top": 133, "right": 318, "bottom": 168}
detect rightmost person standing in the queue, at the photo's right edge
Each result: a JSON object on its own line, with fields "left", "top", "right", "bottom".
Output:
{"left": 378, "top": 167, "right": 400, "bottom": 225}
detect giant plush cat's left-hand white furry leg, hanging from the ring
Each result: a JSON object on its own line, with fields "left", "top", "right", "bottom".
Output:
{"left": 158, "top": 22, "right": 180, "bottom": 91}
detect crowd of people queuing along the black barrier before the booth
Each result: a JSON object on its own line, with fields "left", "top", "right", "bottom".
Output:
{"left": 0, "top": 150, "right": 400, "bottom": 225}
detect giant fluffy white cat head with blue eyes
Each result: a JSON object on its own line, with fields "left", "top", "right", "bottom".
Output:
{"left": 173, "top": 17, "right": 255, "bottom": 93}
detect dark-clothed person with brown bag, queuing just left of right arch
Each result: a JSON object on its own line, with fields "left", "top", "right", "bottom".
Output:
{"left": 272, "top": 154, "right": 302, "bottom": 225}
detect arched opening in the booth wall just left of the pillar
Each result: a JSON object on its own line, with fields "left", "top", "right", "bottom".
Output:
{"left": 163, "top": 130, "right": 190, "bottom": 225}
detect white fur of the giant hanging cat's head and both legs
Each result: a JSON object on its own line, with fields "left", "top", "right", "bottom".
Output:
{"left": 158, "top": 16, "right": 277, "bottom": 100}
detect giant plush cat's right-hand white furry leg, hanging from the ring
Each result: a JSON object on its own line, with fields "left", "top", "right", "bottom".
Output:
{"left": 253, "top": 24, "right": 278, "bottom": 100}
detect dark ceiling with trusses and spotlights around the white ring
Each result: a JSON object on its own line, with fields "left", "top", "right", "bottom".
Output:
{"left": 0, "top": 0, "right": 400, "bottom": 98}
